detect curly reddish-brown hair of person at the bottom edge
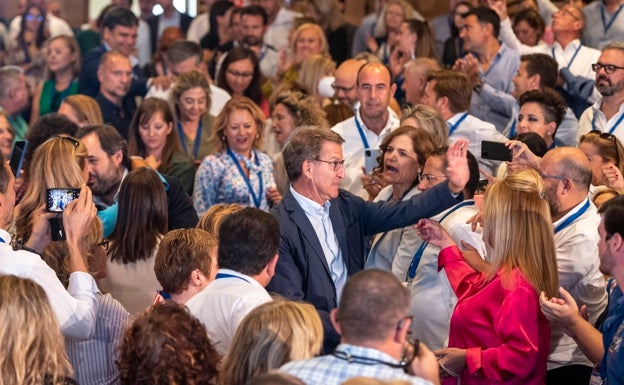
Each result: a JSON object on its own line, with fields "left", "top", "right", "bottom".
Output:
{"left": 117, "top": 301, "right": 220, "bottom": 385}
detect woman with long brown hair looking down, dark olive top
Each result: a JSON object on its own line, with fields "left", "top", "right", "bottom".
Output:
{"left": 128, "top": 98, "right": 195, "bottom": 195}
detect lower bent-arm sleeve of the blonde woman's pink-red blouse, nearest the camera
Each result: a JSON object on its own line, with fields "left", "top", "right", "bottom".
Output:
{"left": 466, "top": 281, "right": 550, "bottom": 381}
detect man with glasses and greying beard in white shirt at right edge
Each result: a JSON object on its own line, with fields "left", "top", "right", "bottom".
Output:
{"left": 578, "top": 43, "right": 624, "bottom": 140}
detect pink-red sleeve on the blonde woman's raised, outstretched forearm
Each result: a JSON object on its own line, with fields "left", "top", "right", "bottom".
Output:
{"left": 438, "top": 246, "right": 483, "bottom": 298}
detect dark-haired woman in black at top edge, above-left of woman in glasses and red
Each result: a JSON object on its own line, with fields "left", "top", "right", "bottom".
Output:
{"left": 199, "top": 0, "right": 235, "bottom": 79}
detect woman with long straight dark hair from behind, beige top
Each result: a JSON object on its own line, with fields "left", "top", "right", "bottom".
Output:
{"left": 99, "top": 167, "right": 167, "bottom": 314}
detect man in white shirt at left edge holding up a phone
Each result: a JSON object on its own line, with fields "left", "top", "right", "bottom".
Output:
{"left": 0, "top": 156, "right": 98, "bottom": 339}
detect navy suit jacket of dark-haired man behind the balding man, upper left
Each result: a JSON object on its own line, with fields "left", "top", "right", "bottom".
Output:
{"left": 78, "top": 45, "right": 147, "bottom": 98}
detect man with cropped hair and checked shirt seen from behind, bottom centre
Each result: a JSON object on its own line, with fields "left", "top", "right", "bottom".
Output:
{"left": 280, "top": 269, "right": 440, "bottom": 385}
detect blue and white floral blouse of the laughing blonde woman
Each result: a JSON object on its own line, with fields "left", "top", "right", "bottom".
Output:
{"left": 193, "top": 150, "right": 275, "bottom": 218}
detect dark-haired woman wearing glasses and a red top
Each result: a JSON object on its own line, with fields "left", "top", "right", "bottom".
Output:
{"left": 217, "top": 47, "right": 270, "bottom": 118}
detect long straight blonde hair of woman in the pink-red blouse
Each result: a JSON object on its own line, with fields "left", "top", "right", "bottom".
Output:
{"left": 483, "top": 169, "right": 559, "bottom": 297}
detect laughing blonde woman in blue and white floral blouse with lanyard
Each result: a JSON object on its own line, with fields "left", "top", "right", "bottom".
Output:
{"left": 193, "top": 96, "right": 282, "bottom": 216}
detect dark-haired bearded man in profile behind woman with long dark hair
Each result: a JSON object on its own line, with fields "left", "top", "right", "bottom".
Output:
{"left": 76, "top": 124, "right": 199, "bottom": 236}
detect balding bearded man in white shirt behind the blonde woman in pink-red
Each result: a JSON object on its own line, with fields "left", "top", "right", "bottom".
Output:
{"left": 538, "top": 147, "right": 607, "bottom": 385}
